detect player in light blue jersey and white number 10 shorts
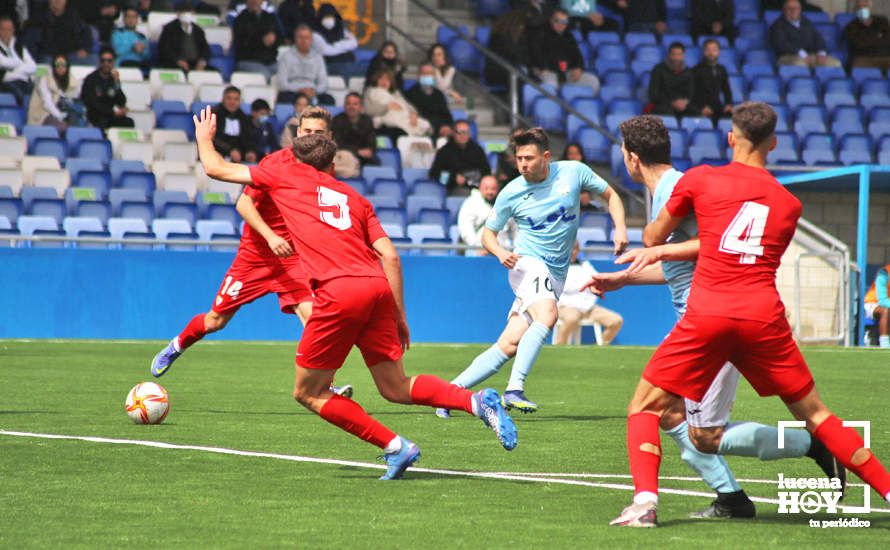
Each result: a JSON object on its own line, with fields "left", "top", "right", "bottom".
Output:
{"left": 436, "top": 128, "right": 627, "bottom": 417}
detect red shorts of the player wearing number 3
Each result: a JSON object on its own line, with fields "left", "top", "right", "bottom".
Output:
{"left": 297, "top": 277, "right": 402, "bottom": 370}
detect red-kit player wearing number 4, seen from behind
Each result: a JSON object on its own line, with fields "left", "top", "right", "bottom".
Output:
{"left": 611, "top": 103, "right": 890, "bottom": 527}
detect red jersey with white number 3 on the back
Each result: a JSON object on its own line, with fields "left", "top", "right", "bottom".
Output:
{"left": 250, "top": 149, "right": 386, "bottom": 288}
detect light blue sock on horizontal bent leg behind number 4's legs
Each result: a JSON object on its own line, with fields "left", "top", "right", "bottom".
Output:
{"left": 718, "top": 422, "right": 813, "bottom": 460}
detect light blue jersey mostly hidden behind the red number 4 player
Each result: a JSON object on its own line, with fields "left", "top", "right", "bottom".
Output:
{"left": 650, "top": 168, "right": 698, "bottom": 319}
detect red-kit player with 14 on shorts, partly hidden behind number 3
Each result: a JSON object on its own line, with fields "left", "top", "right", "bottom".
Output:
{"left": 151, "top": 107, "right": 352, "bottom": 396}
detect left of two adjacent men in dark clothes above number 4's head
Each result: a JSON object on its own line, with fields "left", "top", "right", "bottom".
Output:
{"left": 649, "top": 42, "right": 700, "bottom": 117}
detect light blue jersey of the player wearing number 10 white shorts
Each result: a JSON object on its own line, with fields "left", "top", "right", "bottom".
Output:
{"left": 485, "top": 160, "right": 609, "bottom": 281}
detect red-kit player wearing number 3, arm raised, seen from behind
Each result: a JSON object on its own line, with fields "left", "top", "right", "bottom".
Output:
{"left": 195, "top": 109, "right": 516, "bottom": 479}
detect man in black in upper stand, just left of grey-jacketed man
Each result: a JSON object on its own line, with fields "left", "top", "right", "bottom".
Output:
{"left": 232, "top": 0, "right": 281, "bottom": 82}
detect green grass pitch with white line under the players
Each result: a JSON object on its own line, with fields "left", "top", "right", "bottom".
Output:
{"left": 0, "top": 341, "right": 890, "bottom": 549}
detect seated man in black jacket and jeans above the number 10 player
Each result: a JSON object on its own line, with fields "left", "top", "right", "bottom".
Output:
{"left": 529, "top": 9, "right": 600, "bottom": 95}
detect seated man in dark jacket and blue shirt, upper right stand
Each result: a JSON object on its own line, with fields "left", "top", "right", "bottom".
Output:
{"left": 769, "top": 0, "right": 841, "bottom": 67}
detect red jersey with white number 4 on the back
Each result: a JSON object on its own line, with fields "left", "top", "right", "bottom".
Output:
{"left": 665, "top": 162, "right": 801, "bottom": 322}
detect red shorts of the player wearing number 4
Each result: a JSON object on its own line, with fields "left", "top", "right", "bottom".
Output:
{"left": 643, "top": 314, "right": 813, "bottom": 403}
